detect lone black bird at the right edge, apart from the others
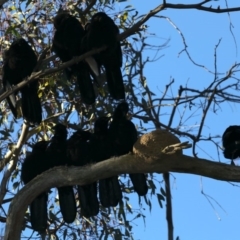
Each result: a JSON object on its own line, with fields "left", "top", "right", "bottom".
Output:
{"left": 222, "top": 125, "right": 240, "bottom": 164}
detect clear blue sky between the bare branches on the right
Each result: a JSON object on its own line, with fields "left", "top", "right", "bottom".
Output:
{"left": 116, "top": 0, "right": 240, "bottom": 240}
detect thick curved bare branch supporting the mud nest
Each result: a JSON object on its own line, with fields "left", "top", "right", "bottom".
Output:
{"left": 4, "top": 148, "right": 240, "bottom": 240}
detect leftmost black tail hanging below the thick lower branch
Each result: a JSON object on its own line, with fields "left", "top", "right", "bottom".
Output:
{"left": 30, "top": 192, "right": 48, "bottom": 232}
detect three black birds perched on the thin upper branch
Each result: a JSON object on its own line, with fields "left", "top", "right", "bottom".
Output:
{"left": 2, "top": 12, "right": 125, "bottom": 124}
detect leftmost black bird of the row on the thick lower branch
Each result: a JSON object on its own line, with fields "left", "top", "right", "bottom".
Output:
{"left": 21, "top": 141, "right": 49, "bottom": 232}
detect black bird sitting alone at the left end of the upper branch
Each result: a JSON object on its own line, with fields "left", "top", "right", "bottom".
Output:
{"left": 2, "top": 38, "right": 42, "bottom": 124}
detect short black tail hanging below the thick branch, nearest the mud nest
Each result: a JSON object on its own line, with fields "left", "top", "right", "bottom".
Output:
{"left": 129, "top": 173, "right": 148, "bottom": 196}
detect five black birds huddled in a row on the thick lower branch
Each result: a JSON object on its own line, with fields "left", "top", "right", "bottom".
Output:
{"left": 21, "top": 102, "right": 148, "bottom": 232}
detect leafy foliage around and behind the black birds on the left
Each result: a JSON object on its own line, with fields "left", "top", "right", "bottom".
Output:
{"left": 1, "top": 0, "right": 165, "bottom": 239}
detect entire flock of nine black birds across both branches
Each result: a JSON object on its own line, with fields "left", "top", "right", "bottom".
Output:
{"left": 2, "top": 7, "right": 240, "bottom": 232}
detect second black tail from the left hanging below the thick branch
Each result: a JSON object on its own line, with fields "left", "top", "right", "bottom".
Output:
{"left": 58, "top": 186, "right": 77, "bottom": 223}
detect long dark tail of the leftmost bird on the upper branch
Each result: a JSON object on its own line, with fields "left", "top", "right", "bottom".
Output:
{"left": 21, "top": 86, "right": 42, "bottom": 124}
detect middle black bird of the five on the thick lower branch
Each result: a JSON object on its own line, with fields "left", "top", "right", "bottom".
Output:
{"left": 68, "top": 130, "right": 99, "bottom": 217}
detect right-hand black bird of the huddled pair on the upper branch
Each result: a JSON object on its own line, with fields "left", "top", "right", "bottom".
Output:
{"left": 82, "top": 12, "right": 125, "bottom": 100}
